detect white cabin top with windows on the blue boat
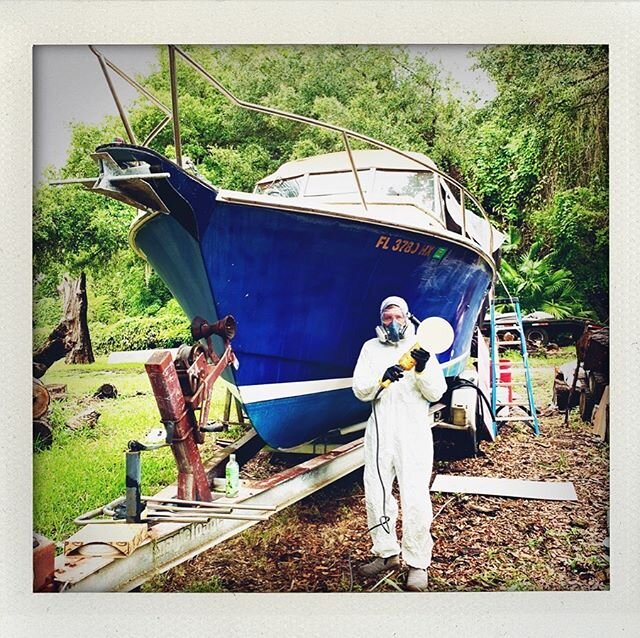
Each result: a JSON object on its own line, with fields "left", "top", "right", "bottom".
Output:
{"left": 245, "top": 150, "right": 504, "bottom": 254}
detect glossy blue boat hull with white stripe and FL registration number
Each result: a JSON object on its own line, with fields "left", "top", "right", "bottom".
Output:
{"left": 101, "top": 146, "right": 492, "bottom": 448}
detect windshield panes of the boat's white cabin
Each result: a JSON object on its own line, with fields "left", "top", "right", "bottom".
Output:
{"left": 256, "top": 169, "right": 435, "bottom": 210}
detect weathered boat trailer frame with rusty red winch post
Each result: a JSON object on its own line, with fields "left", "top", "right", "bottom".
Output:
{"left": 47, "top": 315, "right": 364, "bottom": 592}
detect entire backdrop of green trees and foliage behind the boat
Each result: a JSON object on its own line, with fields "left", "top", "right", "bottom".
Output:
{"left": 33, "top": 45, "right": 608, "bottom": 330}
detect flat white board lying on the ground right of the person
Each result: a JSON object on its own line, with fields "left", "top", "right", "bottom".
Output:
{"left": 431, "top": 474, "right": 578, "bottom": 501}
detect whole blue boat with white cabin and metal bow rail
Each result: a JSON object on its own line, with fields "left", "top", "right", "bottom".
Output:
{"left": 71, "top": 48, "right": 501, "bottom": 449}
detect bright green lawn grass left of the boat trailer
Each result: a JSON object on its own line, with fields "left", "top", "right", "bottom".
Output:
{"left": 33, "top": 358, "right": 230, "bottom": 541}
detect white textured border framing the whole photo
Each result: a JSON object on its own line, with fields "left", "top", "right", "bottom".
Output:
{"left": 0, "top": 0, "right": 640, "bottom": 637}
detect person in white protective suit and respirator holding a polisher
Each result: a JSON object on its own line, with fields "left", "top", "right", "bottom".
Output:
{"left": 353, "top": 297, "right": 447, "bottom": 591}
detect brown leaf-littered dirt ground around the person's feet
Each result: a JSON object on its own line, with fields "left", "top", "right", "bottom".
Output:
{"left": 144, "top": 370, "right": 609, "bottom": 592}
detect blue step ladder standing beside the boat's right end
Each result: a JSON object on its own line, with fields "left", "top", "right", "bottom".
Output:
{"left": 490, "top": 297, "right": 540, "bottom": 436}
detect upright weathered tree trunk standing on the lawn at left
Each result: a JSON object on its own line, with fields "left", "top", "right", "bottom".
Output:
{"left": 58, "top": 273, "right": 95, "bottom": 363}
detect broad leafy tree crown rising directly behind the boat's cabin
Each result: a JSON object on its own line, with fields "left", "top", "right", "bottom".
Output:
{"left": 131, "top": 46, "right": 460, "bottom": 189}
